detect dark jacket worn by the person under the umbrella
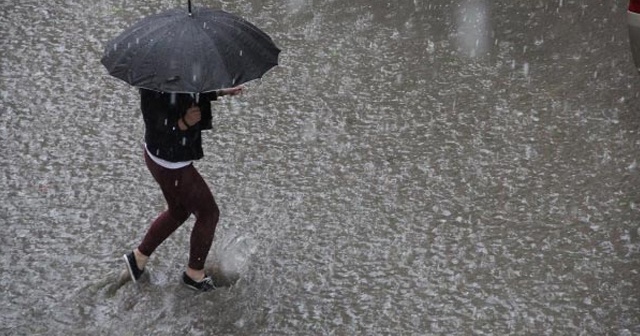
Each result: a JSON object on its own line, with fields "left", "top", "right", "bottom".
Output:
{"left": 140, "top": 89, "right": 218, "bottom": 162}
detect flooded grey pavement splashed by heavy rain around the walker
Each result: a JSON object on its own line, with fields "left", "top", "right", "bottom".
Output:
{"left": 0, "top": 0, "right": 640, "bottom": 335}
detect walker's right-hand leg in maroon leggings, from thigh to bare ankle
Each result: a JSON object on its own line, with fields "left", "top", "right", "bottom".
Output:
{"left": 180, "top": 166, "right": 220, "bottom": 281}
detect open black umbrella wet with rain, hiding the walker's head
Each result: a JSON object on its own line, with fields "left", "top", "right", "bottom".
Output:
{"left": 101, "top": 1, "right": 280, "bottom": 93}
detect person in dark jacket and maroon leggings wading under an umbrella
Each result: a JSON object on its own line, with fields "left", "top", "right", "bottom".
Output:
{"left": 123, "top": 86, "right": 243, "bottom": 291}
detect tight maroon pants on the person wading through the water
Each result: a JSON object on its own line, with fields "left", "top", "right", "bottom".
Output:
{"left": 138, "top": 151, "right": 220, "bottom": 270}
